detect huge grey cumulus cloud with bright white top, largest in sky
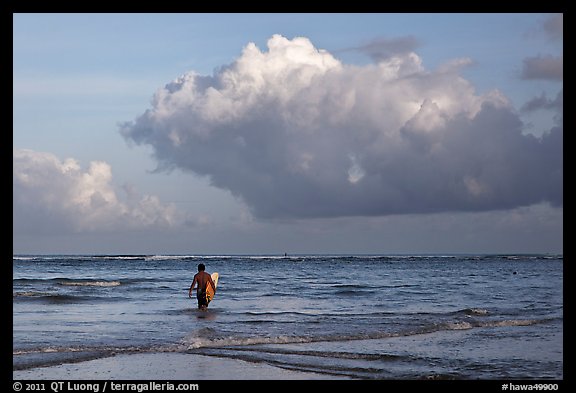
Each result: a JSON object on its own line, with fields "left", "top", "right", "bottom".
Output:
{"left": 120, "top": 35, "right": 562, "bottom": 218}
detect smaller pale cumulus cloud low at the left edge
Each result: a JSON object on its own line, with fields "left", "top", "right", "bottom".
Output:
{"left": 13, "top": 149, "right": 180, "bottom": 232}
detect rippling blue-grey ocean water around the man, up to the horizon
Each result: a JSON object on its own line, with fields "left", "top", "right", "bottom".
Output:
{"left": 13, "top": 255, "right": 564, "bottom": 379}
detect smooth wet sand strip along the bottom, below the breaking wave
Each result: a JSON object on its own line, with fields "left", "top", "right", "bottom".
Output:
{"left": 12, "top": 352, "right": 349, "bottom": 380}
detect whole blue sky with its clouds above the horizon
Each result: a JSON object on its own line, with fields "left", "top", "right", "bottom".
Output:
{"left": 13, "top": 13, "right": 563, "bottom": 255}
